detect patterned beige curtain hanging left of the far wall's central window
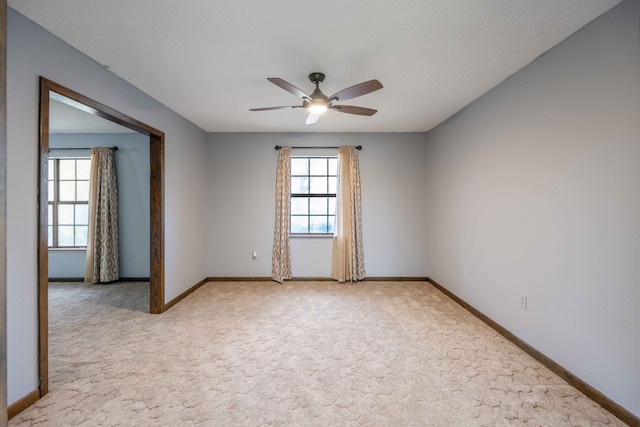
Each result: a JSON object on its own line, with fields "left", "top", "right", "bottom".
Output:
{"left": 271, "top": 147, "right": 291, "bottom": 283}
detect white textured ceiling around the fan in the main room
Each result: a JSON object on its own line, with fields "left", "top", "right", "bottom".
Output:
{"left": 8, "top": 0, "right": 620, "bottom": 132}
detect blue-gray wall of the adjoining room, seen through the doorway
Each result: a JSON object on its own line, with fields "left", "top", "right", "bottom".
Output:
{"left": 49, "top": 133, "right": 150, "bottom": 278}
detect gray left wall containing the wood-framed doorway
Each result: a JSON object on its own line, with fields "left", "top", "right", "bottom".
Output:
{"left": 7, "top": 9, "right": 207, "bottom": 404}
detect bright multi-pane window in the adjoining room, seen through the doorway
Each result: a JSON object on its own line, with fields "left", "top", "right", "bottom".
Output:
{"left": 48, "top": 158, "right": 91, "bottom": 248}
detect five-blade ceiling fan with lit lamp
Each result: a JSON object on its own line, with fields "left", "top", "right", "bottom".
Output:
{"left": 249, "top": 73, "right": 382, "bottom": 125}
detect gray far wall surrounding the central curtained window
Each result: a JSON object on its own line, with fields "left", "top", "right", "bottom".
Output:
{"left": 207, "top": 133, "right": 427, "bottom": 277}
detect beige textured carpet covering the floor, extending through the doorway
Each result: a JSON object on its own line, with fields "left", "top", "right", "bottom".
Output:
{"left": 9, "top": 282, "right": 624, "bottom": 427}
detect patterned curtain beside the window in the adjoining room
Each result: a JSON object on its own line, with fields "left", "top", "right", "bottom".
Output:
{"left": 84, "top": 147, "right": 120, "bottom": 283}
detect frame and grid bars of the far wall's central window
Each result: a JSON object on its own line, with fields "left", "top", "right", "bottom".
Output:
{"left": 289, "top": 154, "right": 338, "bottom": 238}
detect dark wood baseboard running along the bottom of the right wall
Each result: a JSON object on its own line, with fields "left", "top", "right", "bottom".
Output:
{"left": 427, "top": 278, "right": 640, "bottom": 426}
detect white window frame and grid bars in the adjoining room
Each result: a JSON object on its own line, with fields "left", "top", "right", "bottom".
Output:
{"left": 47, "top": 155, "right": 91, "bottom": 251}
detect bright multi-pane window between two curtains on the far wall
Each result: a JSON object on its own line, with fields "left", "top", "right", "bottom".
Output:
{"left": 291, "top": 156, "right": 338, "bottom": 235}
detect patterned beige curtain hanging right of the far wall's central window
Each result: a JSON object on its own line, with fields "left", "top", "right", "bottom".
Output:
{"left": 331, "top": 147, "right": 366, "bottom": 283}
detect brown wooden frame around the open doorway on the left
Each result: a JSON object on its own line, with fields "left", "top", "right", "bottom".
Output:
{"left": 38, "top": 77, "right": 164, "bottom": 397}
